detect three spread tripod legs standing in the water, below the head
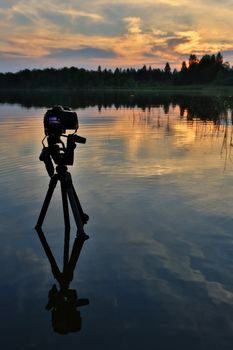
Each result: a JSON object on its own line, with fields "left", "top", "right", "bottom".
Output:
{"left": 35, "top": 164, "right": 89, "bottom": 237}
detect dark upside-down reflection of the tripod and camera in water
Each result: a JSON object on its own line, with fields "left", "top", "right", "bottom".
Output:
{"left": 36, "top": 228, "right": 89, "bottom": 334}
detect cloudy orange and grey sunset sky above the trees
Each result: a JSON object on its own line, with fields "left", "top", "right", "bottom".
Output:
{"left": 0, "top": 0, "right": 233, "bottom": 72}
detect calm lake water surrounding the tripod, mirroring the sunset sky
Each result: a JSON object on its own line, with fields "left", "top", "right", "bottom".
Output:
{"left": 0, "top": 95, "right": 233, "bottom": 350}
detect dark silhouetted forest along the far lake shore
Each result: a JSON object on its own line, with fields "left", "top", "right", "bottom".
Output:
{"left": 0, "top": 52, "right": 233, "bottom": 90}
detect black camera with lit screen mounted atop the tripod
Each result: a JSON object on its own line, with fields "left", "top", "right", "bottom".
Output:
{"left": 44, "top": 106, "right": 79, "bottom": 137}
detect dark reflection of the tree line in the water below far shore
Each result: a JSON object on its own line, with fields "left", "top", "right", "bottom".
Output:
{"left": 0, "top": 91, "right": 233, "bottom": 124}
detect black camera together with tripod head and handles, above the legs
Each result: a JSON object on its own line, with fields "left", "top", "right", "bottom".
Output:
{"left": 39, "top": 106, "right": 86, "bottom": 177}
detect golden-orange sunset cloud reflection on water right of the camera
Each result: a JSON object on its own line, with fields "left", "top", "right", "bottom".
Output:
{"left": 78, "top": 106, "right": 231, "bottom": 190}
